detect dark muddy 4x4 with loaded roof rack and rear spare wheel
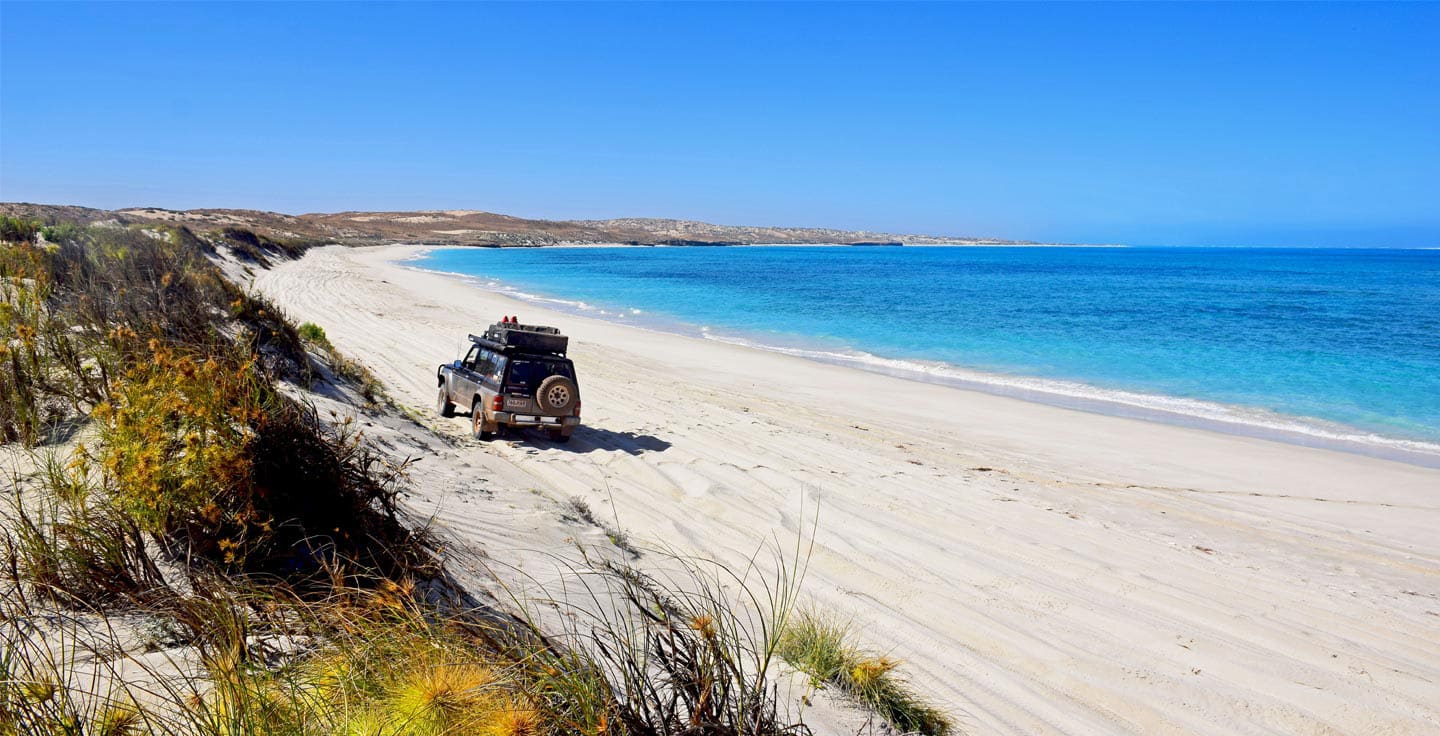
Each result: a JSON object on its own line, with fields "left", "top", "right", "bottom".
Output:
{"left": 435, "top": 317, "right": 580, "bottom": 442}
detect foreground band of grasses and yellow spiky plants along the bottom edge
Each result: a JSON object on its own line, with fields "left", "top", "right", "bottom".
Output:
{"left": 0, "top": 512, "right": 835, "bottom": 736}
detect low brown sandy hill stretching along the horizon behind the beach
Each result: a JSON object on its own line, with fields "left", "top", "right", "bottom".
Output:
{"left": 0, "top": 203, "right": 1025, "bottom": 246}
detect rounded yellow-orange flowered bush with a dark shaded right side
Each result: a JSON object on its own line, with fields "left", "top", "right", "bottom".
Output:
{"left": 94, "top": 340, "right": 426, "bottom": 578}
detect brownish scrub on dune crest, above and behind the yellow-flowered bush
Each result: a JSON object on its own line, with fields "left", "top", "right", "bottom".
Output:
{"left": 0, "top": 226, "right": 311, "bottom": 445}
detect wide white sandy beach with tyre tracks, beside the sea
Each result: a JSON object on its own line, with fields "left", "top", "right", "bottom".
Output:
{"left": 256, "top": 248, "right": 1440, "bottom": 735}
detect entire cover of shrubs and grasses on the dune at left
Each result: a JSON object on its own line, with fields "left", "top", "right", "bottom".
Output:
{"left": 0, "top": 217, "right": 952, "bottom": 736}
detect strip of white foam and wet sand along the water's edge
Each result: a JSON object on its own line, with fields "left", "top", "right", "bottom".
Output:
{"left": 406, "top": 245, "right": 1440, "bottom": 470}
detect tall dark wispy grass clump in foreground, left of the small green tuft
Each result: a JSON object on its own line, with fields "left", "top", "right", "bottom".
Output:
{"left": 498, "top": 550, "right": 808, "bottom": 736}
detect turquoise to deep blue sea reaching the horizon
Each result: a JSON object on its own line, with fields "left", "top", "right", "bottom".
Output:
{"left": 416, "top": 246, "right": 1440, "bottom": 460}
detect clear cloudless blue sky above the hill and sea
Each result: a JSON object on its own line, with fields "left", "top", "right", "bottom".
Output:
{"left": 0, "top": 1, "right": 1440, "bottom": 246}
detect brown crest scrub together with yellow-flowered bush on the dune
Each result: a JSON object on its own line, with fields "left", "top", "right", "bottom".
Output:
{"left": 0, "top": 218, "right": 426, "bottom": 587}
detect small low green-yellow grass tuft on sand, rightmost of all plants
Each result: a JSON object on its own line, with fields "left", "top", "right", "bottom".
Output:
{"left": 779, "top": 611, "right": 955, "bottom": 736}
